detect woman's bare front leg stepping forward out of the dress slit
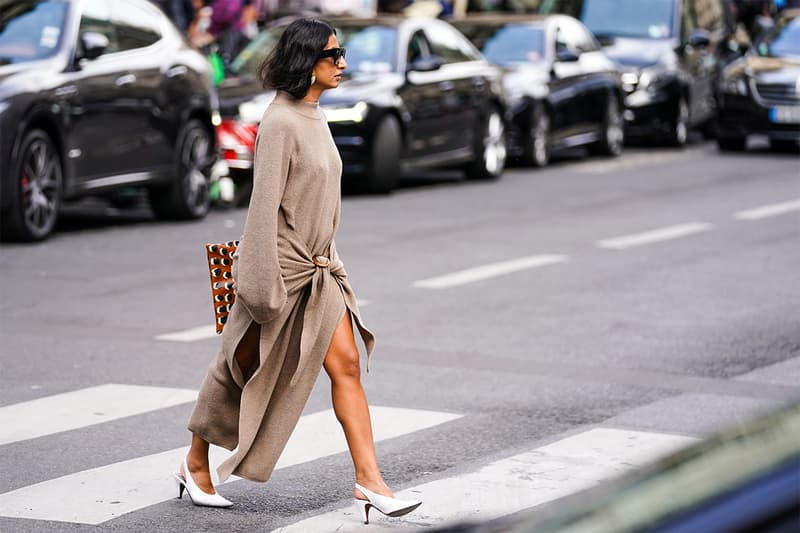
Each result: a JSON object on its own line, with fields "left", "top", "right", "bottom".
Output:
{"left": 325, "top": 311, "right": 394, "bottom": 499}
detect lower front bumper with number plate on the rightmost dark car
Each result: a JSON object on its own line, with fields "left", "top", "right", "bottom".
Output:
{"left": 717, "top": 94, "right": 800, "bottom": 140}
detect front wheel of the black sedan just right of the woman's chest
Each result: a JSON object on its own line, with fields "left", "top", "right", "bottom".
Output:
{"left": 364, "top": 115, "right": 403, "bottom": 194}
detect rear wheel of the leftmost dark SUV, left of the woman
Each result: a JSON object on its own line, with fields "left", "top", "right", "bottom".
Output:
{"left": 148, "top": 120, "right": 214, "bottom": 220}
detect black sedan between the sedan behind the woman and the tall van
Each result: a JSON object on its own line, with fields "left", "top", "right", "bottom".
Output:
{"left": 453, "top": 14, "right": 624, "bottom": 167}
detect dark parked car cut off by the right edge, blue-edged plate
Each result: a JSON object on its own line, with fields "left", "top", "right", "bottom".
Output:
{"left": 717, "top": 9, "right": 800, "bottom": 151}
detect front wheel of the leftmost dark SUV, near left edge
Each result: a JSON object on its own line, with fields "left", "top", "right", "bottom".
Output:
{"left": 0, "top": 129, "right": 63, "bottom": 241}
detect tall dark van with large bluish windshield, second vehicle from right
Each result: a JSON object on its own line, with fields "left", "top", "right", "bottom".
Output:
{"left": 546, "top": 0, "right": 728, "bottom": 146}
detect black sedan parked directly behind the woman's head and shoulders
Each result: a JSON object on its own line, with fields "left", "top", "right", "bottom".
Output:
{"left": 219, "top": 16, "right": 506, "bottom": 193}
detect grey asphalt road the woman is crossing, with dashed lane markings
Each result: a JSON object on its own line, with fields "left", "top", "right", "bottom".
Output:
{"left": 0, "top": 142, "right": 800, "bottom": 532}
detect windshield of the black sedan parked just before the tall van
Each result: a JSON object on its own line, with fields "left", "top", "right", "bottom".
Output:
{"left": 459, "top": 24, "right": 545, "bottom": 66}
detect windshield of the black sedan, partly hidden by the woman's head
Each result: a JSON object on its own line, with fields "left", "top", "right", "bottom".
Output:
{"left": 230, "top": 25, "right": 397, "bottom": 76}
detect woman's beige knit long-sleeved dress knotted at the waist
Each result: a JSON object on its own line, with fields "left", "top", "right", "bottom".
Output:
{"left": 189, "top": 92, "right": 374, "bottom": 481}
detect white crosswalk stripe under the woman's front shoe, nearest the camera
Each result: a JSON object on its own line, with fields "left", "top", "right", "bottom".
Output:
{"left": 273, "top": 428, "right": 696, "bottom": 533}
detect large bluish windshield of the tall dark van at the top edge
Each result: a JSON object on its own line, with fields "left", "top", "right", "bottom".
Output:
{"left": 580, "top": 0, "right": 675, "bottom": 39}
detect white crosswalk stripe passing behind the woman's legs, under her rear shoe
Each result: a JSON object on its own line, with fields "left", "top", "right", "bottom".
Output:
{"left": 0, "top": 407, "right": 462, "bottom": 524}
